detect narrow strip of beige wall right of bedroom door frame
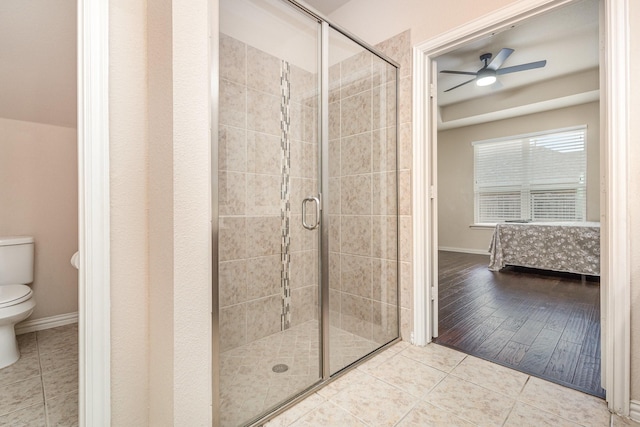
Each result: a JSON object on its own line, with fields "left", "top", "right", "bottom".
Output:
{"left": 628, "top": 0, "right": 640, "bottom": 401}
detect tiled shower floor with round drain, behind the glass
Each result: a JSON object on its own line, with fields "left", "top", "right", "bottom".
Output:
{"left": 220, "top": 321, "right": 381, "bottom": 427}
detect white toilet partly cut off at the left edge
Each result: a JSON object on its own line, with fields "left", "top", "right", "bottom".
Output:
{"left": 0, "top": 236, "right": 36, "bottom": 368}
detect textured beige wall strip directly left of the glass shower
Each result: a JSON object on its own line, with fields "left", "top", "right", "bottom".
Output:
{"left": 169, "top": 0, "right": 212, "bottom": 427}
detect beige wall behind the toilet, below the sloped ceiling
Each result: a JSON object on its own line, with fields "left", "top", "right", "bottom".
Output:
{"left": 0, "top": 118, "right": 78, "bottom": 320}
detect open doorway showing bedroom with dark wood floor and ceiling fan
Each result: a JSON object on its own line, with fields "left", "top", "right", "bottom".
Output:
{"left": 435, "top": 0, "right": 604, "bottom": 397}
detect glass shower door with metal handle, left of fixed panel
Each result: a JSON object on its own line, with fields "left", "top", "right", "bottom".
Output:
{"left": 217, "top": 0, "right": 321, "bottom": 426}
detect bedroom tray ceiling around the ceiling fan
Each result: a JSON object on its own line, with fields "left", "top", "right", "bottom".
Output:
{"left": 436, "top": 0, "right": 599, "bottom": 129}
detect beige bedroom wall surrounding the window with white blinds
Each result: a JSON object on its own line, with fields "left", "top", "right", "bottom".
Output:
{"left": 438, "top": 102, "right": 600, "bottom": 251}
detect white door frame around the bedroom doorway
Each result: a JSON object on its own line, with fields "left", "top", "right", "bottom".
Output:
{"left": 412, "top": 0, "right": 630, "bottom": 416}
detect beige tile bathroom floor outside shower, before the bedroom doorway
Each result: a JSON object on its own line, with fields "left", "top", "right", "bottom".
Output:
{"left": 265, "top": 342, "right": 640, "bottom": 427}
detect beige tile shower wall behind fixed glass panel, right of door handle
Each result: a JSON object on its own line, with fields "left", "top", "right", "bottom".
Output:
{"left": 329, "top": 29, "right": 411, "bottom": 343}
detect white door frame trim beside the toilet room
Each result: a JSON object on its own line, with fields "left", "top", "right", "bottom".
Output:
{"left": 77, "top": 0, "right": 111, "bottom": 427}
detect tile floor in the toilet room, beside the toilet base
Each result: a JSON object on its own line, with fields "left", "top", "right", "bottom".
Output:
{"left": 0, "top": 324, "right": 78, "bottom": 427}
